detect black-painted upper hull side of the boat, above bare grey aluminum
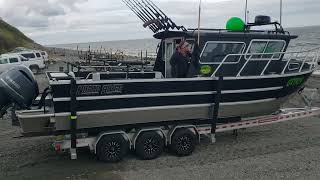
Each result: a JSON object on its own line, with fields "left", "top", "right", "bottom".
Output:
{"left": 51, "top": 72, "right": 311, "bottom": 113}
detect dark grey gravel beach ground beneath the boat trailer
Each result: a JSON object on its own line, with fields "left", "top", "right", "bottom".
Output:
{"left": 0, "top": 61, "right": 320, "bottom": 180}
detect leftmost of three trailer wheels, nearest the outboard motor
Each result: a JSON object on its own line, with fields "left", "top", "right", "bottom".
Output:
{"left": 97, "top": 134, "right": 129, "bottom": 162}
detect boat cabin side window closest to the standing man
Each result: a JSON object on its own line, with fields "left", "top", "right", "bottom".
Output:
{"left": 200, "top": 41, "right": 245, "bottom": 64}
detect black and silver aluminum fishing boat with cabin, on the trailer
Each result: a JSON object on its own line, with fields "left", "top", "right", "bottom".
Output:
{"left": 0, "top": 0, "right": 319, "bottom": 134}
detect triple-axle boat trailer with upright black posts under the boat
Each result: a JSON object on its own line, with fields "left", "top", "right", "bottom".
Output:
{"left": 53, "top": 77, "right": 320, "bottom": 162}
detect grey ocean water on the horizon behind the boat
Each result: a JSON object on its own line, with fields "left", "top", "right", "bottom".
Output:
{"left": 50, "top": 26, "right": 320, "bottom": 55}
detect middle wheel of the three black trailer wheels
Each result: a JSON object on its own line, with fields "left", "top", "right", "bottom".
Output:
{"left": 135, "top": 131, "right": 165, "bottom": 160}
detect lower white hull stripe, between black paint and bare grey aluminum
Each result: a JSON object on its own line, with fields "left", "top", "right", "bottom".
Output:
{"left": 55, "top": 98, "right": 276, "bottom": 117}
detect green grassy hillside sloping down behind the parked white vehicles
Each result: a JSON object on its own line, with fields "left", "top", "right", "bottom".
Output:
{"left": 0, "top": 19, "right": 39, "bottom": 54}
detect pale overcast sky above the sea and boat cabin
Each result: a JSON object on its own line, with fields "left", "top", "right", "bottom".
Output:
{"left": 0, "top": 0, "right": 320, "bottom": 44}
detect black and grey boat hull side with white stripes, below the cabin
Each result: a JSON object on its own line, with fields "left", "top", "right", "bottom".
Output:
{"left": 17, "top": 72, "right": 311, "bottom": 133}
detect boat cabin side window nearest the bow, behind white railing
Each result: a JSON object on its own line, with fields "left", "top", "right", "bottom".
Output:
{"left": 246, "top": 40, "right": 286, "bottom": 60}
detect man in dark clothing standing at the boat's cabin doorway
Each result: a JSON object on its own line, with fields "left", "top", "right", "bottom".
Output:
{"left": 170, "top": 41, "right": 191, "bottom": 78}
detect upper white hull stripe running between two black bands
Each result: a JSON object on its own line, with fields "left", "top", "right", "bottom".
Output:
{"left": 53, "top": 86, "right": 283, "bottom": 102}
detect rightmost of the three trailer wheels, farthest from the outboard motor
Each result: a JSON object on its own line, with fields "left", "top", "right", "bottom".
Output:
{"left": 170, "top": 128, "right": 197, "bottom": 156}
